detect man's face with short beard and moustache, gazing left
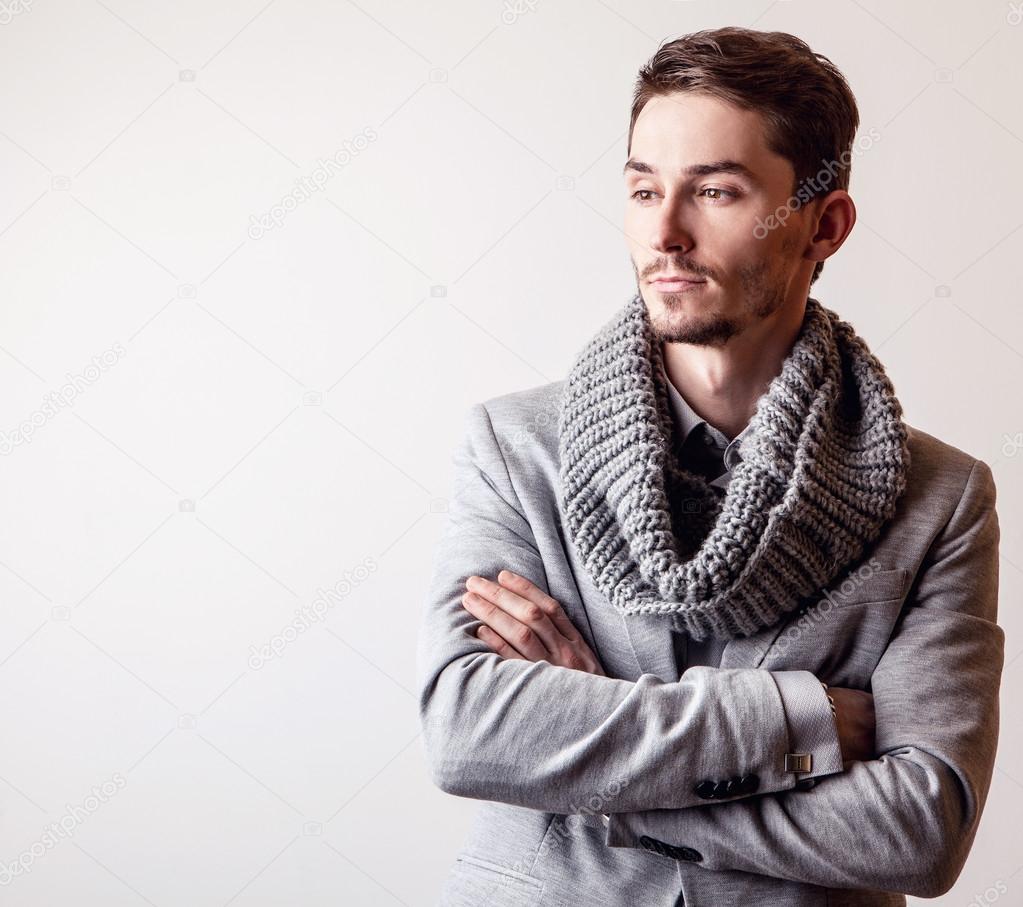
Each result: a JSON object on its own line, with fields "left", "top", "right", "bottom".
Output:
{"left": 625, "top": 92, "right": 813, "bottom": 347}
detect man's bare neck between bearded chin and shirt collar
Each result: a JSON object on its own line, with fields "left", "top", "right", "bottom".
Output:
{"left": 662, "top": 301, "right": 805, "bottom": 438}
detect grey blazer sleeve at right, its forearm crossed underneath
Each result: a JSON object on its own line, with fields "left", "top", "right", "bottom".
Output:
{"left": 607, "top": 460, "right": 1005, "bottom": 898}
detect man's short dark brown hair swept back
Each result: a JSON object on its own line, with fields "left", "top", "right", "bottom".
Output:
{"left": 628, "top": 28, "right": 859, "bottom": 283}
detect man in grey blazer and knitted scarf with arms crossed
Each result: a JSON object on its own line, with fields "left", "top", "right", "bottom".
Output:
{"left": 418, "top": 29, "right": 1004, "bottom": 907}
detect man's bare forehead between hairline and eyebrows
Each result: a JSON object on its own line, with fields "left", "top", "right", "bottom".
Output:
{"left": 630, "top": 92, "right": 793, "bottom": 179}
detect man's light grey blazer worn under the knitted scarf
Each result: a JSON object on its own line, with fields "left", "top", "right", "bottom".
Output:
{"left": 416, "top": 381, "right": 1005, "bottom": 907}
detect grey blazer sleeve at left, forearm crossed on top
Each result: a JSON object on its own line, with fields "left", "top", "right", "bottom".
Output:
{"left": 416, "top": 404, "right": 814, "bottom": 814}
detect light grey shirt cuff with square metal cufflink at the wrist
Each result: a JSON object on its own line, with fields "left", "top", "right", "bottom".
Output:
{"left": 771, "top": 671, "right": 843, "bottom": 787}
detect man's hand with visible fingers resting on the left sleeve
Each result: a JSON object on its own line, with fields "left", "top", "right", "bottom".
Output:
{"left": 461, "top": 570, "right": 607, "bottom": 677}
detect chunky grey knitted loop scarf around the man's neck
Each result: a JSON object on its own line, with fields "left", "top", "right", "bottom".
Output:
{"left": 559, "top": 293, "right": 909, "bottom": 640}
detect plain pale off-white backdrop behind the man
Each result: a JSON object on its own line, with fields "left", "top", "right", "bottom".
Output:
{"left": 0, "top": 0, "right": 1023, "bottom": 907}
